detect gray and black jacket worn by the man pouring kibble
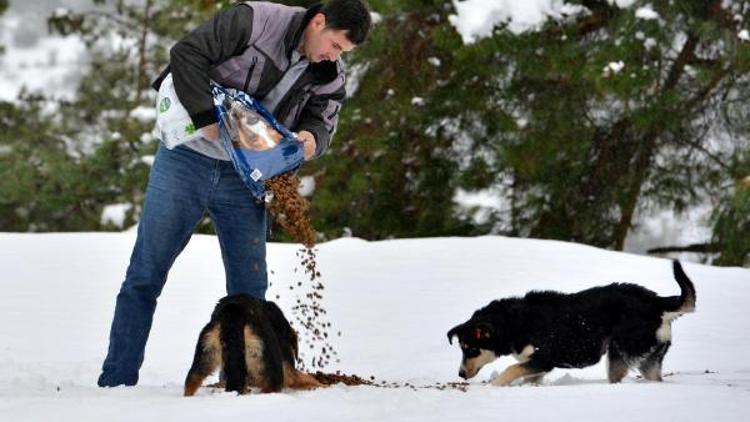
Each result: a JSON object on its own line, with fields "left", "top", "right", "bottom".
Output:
{"left": 153, "top": 2, "right": 346, "bottom": 157}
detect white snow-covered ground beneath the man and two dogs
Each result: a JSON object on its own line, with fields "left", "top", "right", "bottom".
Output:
{"left": 0, "top": 232, "right": 750, "bottom": 422}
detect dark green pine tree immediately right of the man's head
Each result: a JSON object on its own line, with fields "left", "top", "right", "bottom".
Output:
{"left": 305, "top": 1, "right": 484, "bottom": 239}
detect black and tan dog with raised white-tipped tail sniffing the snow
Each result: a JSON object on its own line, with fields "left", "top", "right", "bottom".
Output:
{"left": 448, "top": 261, "right": 695, "bottom": 385}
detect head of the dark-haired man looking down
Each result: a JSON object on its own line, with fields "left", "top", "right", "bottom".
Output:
{"left": 303, "top": 0, "right": 371, "bottom": 63}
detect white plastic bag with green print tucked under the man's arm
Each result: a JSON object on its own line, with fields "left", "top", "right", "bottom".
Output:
{"left": 156, "top": 73, "right": 201, "bottom": 149}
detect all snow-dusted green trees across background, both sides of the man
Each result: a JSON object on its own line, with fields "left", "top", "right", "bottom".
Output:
{"left": 0, "top": 0, "right": 750, "bottom": 265}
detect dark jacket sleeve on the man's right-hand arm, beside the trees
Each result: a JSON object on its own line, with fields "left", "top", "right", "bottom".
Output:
{"left": 293, "top": 78, "right": 346, "bottom": 158}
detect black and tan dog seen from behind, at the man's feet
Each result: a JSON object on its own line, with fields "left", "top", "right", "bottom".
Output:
{"left": 185, "top": 294, "right": 323, "bottom": 396}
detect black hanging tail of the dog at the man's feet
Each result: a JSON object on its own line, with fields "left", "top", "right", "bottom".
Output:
{"left": 221, "top": 304, "right": 247, "bottom": 394}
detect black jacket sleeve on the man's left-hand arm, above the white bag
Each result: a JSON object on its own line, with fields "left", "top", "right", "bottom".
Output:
{"left": 169, "top": 4, "right": 253, "bottom": 128}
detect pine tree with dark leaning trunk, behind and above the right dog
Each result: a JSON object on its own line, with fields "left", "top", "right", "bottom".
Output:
{"left": 490, "top": 1, "right": 747, "bottom": 249}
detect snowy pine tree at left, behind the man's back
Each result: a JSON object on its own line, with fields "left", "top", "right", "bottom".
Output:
{"left": 0, "top": 0, "right": 236, "bottom": 231}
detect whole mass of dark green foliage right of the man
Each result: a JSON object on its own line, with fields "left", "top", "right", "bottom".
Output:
{"left": 308, "top": 1, "right": 750, "bottom": 266}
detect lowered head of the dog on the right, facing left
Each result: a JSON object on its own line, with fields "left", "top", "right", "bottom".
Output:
{"left": 448, "top": 319, "right": 498, "bottom": 379}
